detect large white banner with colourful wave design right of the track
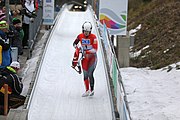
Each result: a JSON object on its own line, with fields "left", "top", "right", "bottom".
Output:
{"left": 99, "top": 0, "right": 128, "bottom": 35}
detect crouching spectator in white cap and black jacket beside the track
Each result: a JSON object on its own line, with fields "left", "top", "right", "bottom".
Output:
{"left": 0, "top": 61, "right": 24, "bottom": 114}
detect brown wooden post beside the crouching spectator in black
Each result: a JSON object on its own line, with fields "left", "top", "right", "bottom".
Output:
{"left": 4, "top": 84, "right": 8, "bottom": 116}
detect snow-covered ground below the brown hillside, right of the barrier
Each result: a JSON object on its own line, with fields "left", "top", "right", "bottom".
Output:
{"left": 120, "top": 63, "right": 180, "bottom": 120}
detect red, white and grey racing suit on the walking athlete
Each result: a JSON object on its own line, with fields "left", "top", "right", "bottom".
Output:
{"left": 73, "top": 33, "right": 98, "bottom": 91}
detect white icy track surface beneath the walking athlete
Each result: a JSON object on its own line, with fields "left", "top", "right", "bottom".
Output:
{"left": 28, "top": 9, "right": 112, "bottom": 120}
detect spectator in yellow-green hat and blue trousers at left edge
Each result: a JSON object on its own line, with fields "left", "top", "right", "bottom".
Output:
{"left": 0, "top": 21, "right": 11, "bottom": 68}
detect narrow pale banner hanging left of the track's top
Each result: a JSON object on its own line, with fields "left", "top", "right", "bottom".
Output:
{"left": 43, "top": 0, "right": 54, "bottom": 25}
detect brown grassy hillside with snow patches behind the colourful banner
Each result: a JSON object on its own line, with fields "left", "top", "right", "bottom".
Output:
{"left": 128, "top": 0, "right": 180, "bottom": 69}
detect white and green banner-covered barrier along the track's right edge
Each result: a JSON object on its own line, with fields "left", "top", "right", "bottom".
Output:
{"left": 89, "top": 4, "right": 131, "bottom": 120}
